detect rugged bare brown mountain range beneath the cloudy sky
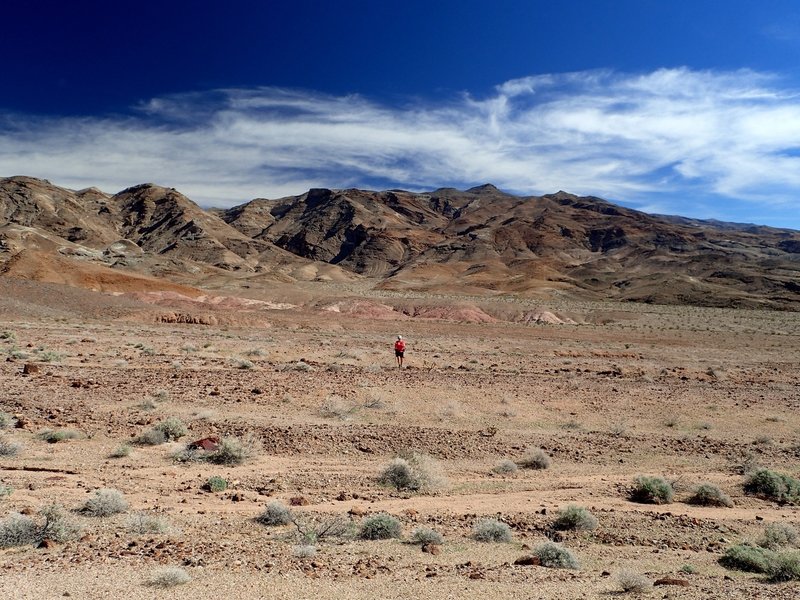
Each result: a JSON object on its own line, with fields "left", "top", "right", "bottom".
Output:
{"left": 0, "top": 176, "right": 800, "bottom": 310}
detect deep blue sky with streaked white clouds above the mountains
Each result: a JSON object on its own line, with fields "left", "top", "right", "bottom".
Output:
{"left": 0, "top": 0, "right": 800, "bottom": 229}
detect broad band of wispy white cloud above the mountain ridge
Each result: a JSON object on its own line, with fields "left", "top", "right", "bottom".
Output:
{"left": 0, "top": 69, "right": 800, "bottom": 226}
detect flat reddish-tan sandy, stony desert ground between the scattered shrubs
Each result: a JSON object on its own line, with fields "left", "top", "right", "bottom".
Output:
{"left": 0, "top": 282, "right": 800, "bottom": 599}
